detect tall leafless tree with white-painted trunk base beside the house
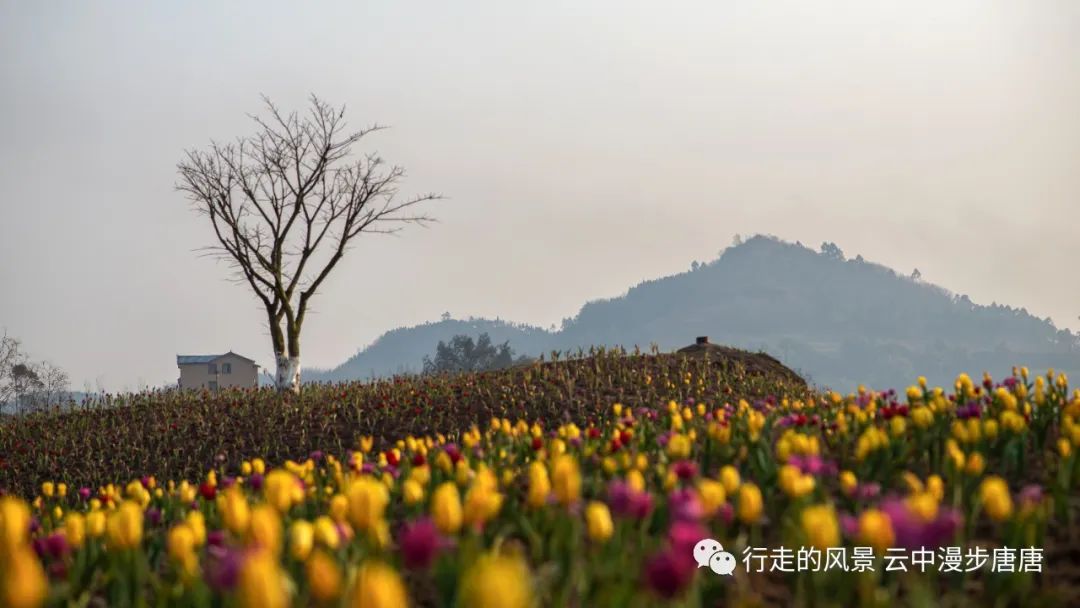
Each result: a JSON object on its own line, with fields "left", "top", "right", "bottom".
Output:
{"left": 177, "top": 96, "right": 438, "bottom": 392}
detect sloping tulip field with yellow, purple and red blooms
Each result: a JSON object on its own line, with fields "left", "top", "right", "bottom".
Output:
{"left": 0, "top": 350, "right": 1080, "bottom": 608}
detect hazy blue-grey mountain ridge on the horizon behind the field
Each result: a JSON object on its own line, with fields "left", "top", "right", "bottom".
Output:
{"left": 305, "top": 237, "right": 1080, "bottom": 391}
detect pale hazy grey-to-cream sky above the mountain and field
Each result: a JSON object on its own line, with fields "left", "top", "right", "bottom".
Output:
{"left": 0, "top": 0, "right": 1080, "bottom": 390}
